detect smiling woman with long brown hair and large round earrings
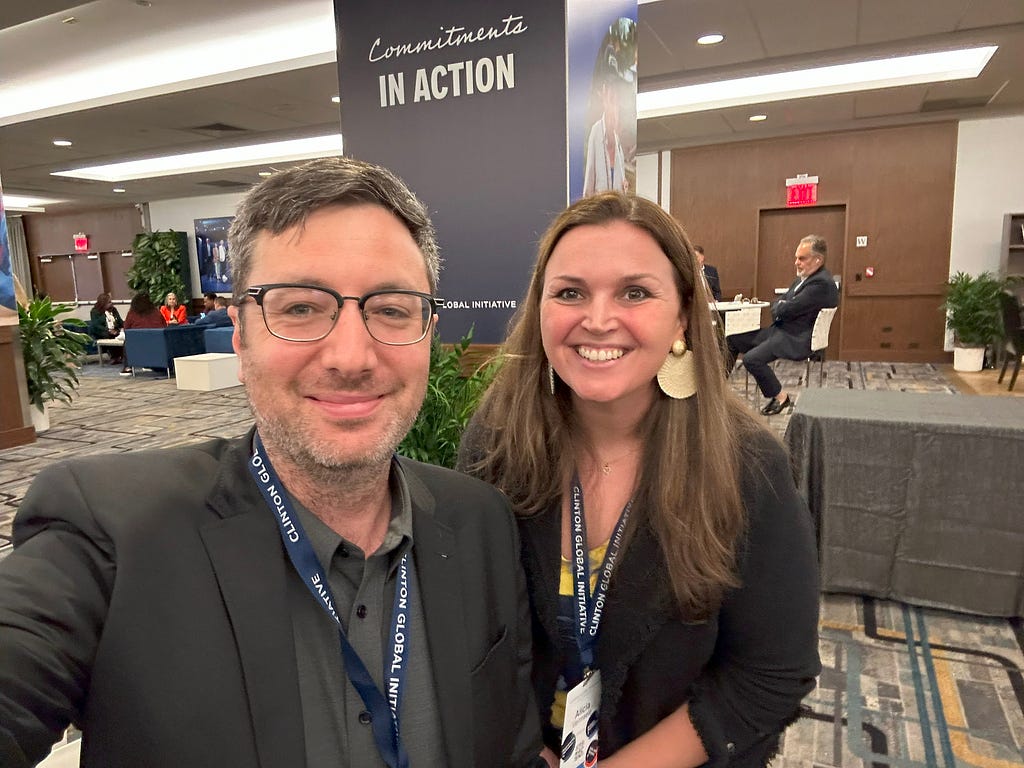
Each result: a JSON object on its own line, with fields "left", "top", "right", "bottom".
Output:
{"left": 461, "top": 193, "right": 820, "bottom": 768}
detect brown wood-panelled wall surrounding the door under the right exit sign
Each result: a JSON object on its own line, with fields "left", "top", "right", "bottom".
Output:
{"left": 671, "top": 123, "right": 956, "bottom": 361}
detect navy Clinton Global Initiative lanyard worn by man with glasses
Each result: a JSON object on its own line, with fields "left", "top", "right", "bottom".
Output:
{"left": 249, "top": 433, "right": 414, "bottom": 768}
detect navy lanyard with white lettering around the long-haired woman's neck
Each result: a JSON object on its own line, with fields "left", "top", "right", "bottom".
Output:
{"left": 570, "top": 474, "right": 633, "bottom": 670}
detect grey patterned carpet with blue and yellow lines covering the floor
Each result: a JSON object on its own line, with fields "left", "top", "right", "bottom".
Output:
{"left": 0, "top": 361, "right": 1024, "bottom": 768}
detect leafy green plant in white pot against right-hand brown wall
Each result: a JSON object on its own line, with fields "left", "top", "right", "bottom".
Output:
{"left": 942, "top": 272, "right": 1004, "bottom": 371}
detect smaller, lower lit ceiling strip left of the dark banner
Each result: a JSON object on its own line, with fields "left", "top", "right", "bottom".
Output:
{"left": 50, "top": 133, "right": 342, "bottom": 181}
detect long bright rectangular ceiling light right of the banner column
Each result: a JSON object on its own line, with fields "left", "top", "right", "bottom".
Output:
{"left": 637, "top": 45, "right": 998, "bottom": 120}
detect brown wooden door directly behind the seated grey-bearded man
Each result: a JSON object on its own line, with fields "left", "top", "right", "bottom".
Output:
{"left": 755, "top": 206, "right": 846, "bottom": 359}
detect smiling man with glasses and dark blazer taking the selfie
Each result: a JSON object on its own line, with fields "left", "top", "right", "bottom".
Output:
{"left": 0, "top": 159, "right": 545, "bottom": 768}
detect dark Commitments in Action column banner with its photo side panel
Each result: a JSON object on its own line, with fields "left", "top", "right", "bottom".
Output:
{"left": 335, "top": 0, "right": 636, "bottom": 344}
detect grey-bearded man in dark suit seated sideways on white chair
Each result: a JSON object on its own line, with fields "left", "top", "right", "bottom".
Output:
{"left": 728, "top": 234, "right": 839, "bottom": 416}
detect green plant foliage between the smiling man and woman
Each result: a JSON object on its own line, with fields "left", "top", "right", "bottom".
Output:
{"left": 398, "top": 329, "right": 498, "bottom": 468}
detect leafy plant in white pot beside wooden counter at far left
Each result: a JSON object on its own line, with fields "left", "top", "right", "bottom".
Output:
{"left": 17, "top": 297, "right": 89, "bottom": 432}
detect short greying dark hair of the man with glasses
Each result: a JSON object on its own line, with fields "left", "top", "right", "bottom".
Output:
{"left": 227, "top": 158, "right": 440, "bottom": 302}
